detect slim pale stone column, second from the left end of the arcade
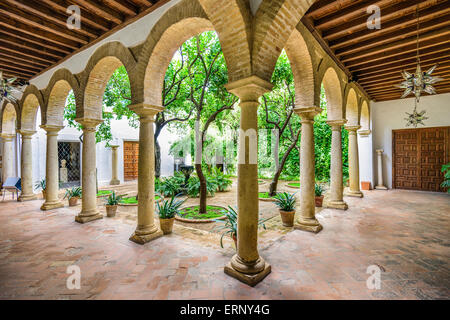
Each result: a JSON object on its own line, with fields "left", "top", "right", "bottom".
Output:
{"left": 18, "top": 130, "right": 37, "bottom": 201}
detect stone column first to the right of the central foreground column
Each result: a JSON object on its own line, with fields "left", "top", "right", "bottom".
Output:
{"left": 294, "top": 107, "right": 322, "bottom": 233}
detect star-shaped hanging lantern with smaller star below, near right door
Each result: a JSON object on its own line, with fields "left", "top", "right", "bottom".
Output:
{"left": 397, "top": 5, "right": 442, "bottom": 127}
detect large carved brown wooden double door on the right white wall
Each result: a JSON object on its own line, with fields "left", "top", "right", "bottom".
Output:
{"left": 392, "top": 127, "right": 450, "bottom": 191}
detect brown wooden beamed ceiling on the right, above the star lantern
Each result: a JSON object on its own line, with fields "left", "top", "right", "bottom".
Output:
{"left": 302, "top": 0, "right": 450, "bottom": 101}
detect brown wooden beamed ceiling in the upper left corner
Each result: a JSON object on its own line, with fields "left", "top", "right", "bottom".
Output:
{"left": 0, "top": 0, "right": 169, "bottom": 82}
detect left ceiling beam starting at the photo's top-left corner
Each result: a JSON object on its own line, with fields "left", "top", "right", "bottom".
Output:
{"left": 5, "top": 0, "right": 100, "bottom": 39}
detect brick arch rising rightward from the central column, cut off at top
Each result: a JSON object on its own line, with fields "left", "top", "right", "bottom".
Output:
{"left": 252, "top": 0, "right": 315, "bottom": 81}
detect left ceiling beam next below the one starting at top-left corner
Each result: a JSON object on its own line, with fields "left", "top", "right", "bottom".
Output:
{"left": 0, "top": 12, "right": 80, "bottom": 49}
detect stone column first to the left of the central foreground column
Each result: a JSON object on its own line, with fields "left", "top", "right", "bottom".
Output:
{"left": 128, "top": 104, "right": 164, "bottom": 244}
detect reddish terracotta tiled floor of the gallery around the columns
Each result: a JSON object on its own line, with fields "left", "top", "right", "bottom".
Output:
{"left": 0, "top": 191, "right": 450, "bottom": 299}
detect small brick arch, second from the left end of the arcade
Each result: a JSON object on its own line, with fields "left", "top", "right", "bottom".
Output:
{"left": 19, "top": 85, "right": 44, "bottom": 131}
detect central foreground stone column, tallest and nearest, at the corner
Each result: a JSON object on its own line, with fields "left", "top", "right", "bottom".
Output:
{"left": 224, "top": 76, "right": 272, "bottom": 286}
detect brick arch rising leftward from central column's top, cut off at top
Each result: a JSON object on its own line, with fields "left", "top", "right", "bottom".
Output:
{"left": 197, "top": 0, "right": 253, "bottom": 83}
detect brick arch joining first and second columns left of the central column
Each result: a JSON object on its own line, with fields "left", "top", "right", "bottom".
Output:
{"left": 77, "top": 41, "right": 136, "bottom": 120}
